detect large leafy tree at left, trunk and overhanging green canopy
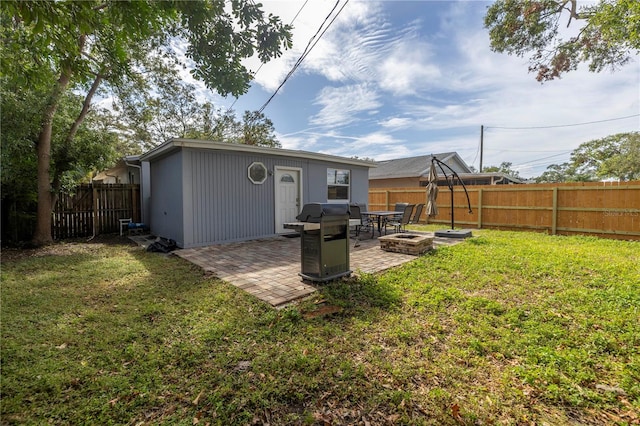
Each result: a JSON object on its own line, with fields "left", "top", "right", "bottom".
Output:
{"left": 0, "top": 0, "right": 291, "bottom": 244}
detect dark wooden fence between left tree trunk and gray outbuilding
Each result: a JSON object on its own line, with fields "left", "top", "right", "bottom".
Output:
{"left": 51, "top": 184, "right": 140, "bottom": 239}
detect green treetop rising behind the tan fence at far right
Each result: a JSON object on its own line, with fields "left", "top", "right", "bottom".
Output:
{"left": 536, "top": 132, "right": 640, "bottom": 182}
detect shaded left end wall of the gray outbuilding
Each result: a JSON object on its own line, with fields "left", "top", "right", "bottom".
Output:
{"left": 149, "top": 151, "right": 184, "bottom": 245}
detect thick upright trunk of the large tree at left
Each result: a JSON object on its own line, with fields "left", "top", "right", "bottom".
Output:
{"left": 32, "top": 69, "right": 71, "bottom": 246}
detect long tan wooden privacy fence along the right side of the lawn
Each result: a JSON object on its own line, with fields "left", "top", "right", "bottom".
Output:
{"left": 369, "top": 181, "right": 640, "bottom": 240}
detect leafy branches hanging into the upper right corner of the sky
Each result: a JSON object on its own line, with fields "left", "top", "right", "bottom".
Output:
{"left": 485, "top": 0, "right": 640, "bottom": 81}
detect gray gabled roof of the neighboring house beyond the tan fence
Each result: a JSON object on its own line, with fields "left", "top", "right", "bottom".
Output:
{"left": 369, "top": 152, "right": 471, "bottom": 179}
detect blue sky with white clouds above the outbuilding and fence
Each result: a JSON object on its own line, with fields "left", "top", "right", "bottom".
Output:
{"left": 196, "top": 0, "right": 640, "bottom": 177}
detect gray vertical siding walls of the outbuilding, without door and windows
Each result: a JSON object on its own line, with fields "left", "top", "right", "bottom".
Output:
{"left": 151, "top": 148, "right": 369, "bottom": 248}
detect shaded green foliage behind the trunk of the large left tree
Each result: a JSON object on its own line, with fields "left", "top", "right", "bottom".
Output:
{"left": 0, "top": 82, "right": 129, "bottom": 243}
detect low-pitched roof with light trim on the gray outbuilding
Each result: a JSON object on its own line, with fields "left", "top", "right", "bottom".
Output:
{"left": 140, "top": 139, "right": 376, "bottom": 168}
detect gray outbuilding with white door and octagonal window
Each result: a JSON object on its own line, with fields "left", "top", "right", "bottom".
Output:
{"left": 140, "top": 139, "right": 375, "bottom": 248}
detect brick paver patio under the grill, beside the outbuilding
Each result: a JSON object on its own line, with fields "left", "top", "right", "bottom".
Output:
{"left": 173, "top": 231, "right": 462, "bottom": 307}
